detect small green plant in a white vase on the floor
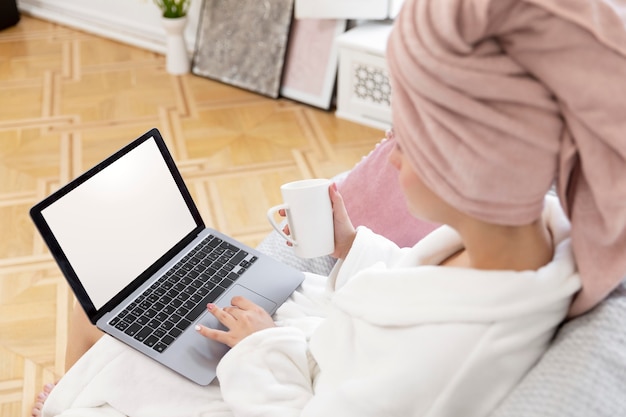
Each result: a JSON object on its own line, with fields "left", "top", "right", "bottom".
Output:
{"left": 154, "top": 0, "right": 191, "bottom": 74}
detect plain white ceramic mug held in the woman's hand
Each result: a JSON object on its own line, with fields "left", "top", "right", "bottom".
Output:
{"left": 267, "top": 178, "right": 335, "bottom": 258}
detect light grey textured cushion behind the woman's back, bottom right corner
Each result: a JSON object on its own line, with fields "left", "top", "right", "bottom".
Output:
{"left": 491, "top": 281, "right": 626, "bottom": 417}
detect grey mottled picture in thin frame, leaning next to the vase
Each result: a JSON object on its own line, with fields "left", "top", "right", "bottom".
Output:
{"left": 191, "top": 0, "right": 293, "bottom": 98}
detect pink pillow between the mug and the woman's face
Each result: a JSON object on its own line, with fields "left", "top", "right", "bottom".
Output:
{"left": 337, "top": 139, "right": 437, "bottom": 247}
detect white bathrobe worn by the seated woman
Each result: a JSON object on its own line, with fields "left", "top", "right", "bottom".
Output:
{"left": 44, "top": 199, "right": 580, "bottom": 417}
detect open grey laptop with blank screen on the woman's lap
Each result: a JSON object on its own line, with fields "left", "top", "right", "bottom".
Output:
{"left": 30, "top": 129, "right": 304, "bottom": 385}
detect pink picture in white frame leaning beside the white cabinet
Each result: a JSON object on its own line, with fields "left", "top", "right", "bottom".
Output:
{"left": 280, "top": 19, "right": 347, "bottom": 110}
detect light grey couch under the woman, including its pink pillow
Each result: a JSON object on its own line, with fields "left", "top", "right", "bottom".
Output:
{"left": 258, "top": 137, "right": 626, "bottom": 417}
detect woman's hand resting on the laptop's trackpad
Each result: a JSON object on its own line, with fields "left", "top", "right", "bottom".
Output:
{"left": 196, "top": 296, "right": 276, "bottom": 347}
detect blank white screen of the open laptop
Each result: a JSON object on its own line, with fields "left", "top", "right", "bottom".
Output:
{"left": 42, "top": 139, "right": 196, "bottom": 309}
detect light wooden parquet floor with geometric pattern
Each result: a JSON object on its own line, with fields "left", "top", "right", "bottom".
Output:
{"left": 0, "top": 16, "right": 383, "bottom": 417}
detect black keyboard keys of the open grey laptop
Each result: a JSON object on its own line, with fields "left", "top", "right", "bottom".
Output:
{"left": 109, "top": 235, "right": 257, "bottom": 352}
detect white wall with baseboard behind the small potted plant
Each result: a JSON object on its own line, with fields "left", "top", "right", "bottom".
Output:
{"left": 18, "top": 0, "right": 202, "bottom": 53}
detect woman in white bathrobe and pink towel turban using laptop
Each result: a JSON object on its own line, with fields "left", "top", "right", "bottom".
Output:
{"left": 36, "top": 0, "right": 626, "bottom": 417}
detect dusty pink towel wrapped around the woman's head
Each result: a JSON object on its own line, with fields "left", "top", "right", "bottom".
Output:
{"left": 387, "top": 0, "right": 626, "bottom": 316}
